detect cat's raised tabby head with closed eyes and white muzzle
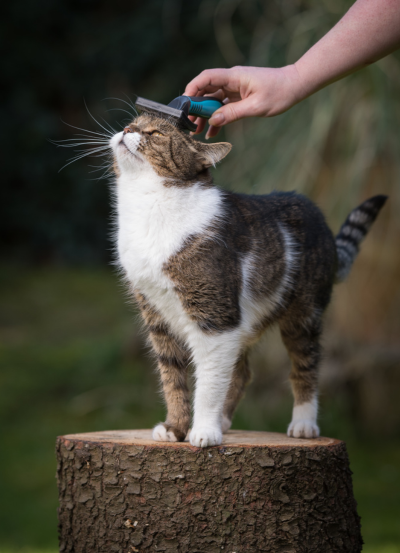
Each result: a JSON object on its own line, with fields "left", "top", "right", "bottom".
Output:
{"left": 110, "top": 114, "right": 232, "bottom": 184}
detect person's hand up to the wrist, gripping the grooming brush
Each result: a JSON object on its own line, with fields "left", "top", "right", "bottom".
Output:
{"left": 185, "top": 65, "right": 304, "bottom": 138}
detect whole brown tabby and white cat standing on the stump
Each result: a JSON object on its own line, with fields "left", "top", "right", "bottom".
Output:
{"left": 110, "top": 114, "right": 386, "bottom": 447}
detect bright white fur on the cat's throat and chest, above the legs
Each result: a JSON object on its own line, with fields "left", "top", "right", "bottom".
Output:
{"left": 117, "top": 168, "right": 222, "bottom": 332}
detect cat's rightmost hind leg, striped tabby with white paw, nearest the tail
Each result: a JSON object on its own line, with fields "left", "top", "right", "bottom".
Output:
{"left": 279, "top": 316, "right": 321, "bottom": 438}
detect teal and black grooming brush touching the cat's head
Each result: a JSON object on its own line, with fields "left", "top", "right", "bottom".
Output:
{"left": 135, "top": 96, "right": 224, "bottom": 131}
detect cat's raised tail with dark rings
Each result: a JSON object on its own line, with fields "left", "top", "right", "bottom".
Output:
{"left": 335, "top": 195, "right": 387, "bottom": 282}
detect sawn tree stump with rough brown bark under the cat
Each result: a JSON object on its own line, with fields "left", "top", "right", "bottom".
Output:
{"left": 57, "top": 430, "right": 362, "bottom": 553}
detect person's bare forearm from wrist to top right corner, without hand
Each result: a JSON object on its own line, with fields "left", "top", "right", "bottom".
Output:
{"left": 294, "top": 0, "right": 400, "bottom": 101}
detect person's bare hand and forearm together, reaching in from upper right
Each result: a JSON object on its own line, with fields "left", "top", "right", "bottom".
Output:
{"left": 185, "top": 0, "right": 400, "bottom": 138}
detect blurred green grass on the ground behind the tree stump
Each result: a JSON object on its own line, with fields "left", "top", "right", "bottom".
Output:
{"left": 0, "top": 269, "right": 400, "bottom": 553}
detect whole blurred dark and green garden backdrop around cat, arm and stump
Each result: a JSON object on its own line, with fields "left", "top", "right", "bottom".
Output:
{"left": 0, "top": 0, "right": 400, "bottom": 553}
